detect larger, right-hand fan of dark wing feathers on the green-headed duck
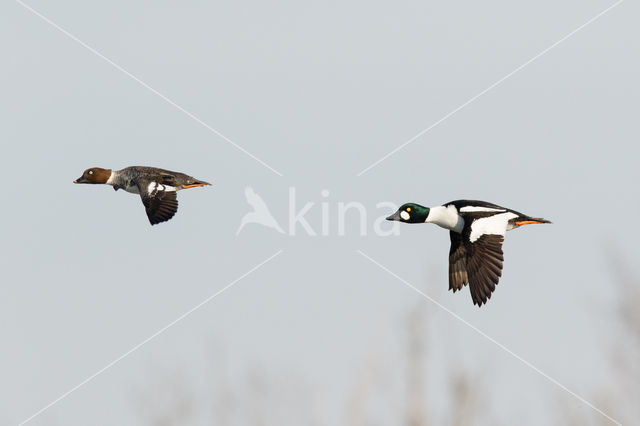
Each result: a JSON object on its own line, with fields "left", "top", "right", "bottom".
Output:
{"left": 463, "top": 234, "right": 504, "bottom": 306}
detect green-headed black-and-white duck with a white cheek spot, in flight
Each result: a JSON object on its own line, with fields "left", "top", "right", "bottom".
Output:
{"left": 386, "top": 200, "right": 551, "bottom": 307}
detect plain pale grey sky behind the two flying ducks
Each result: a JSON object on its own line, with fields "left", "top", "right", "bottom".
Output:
{"left": 0, "top": 0, "right": 640, "bottom": 425}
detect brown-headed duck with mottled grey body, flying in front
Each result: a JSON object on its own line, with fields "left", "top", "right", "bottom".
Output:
{"left": 73, "top": 166, "right": 211, "bottom": 225}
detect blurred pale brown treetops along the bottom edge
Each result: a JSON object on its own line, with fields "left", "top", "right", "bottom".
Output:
{"left": 135, "top": 256, "right": 640, "bottom": 426}
